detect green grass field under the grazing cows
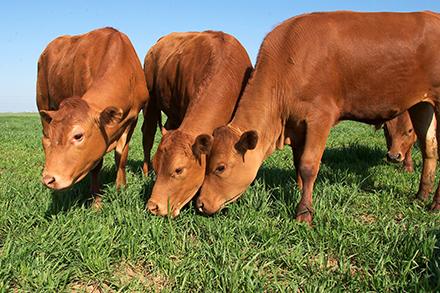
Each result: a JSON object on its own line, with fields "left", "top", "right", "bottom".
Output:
{"left": 0, "top": 115, "right": 440, "bottom": 292}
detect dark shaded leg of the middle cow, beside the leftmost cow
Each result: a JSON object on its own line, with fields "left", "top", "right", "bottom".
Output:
{"left": 142, "top": 99, "right": 160, "bottom": 176}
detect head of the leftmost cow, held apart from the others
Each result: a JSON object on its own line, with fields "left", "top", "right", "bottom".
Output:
{"left": 40, "top": 97, "right": 122, "bottom": 190}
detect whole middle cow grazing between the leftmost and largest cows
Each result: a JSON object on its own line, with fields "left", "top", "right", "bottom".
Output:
{"left": 142, "top": 31, "right": 252, "bottom": 217}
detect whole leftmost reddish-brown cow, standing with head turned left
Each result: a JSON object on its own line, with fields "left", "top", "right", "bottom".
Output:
{"left": 37, "top": 28, "right": 148, "bottom": 206}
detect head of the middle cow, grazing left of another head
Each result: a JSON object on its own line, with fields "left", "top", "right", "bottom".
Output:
{"left": 147, "top": 130, "right": 212, "bottom": 217}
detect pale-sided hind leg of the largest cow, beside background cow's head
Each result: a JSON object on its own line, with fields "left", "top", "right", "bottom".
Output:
{"left": 409, "top": 103, "right": 437, "bottom": 201}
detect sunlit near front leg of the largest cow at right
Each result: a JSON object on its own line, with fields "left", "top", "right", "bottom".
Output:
{"left": 296, "top": 114, "right": 333, "bottom": 225}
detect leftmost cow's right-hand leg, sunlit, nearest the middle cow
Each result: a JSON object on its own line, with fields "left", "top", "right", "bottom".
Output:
{"left": 115, "top": 119, "right": 137, "bottom": 189}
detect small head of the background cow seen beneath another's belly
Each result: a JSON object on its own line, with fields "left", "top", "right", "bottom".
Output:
{"left": 383, "top": 112, "right": 417, "bottom": 162}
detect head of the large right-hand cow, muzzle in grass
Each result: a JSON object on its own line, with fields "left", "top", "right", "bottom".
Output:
{"left": 196, "top": 126, "right": 262, "bottom": 215}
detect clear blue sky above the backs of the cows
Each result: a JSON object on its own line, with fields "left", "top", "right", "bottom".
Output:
{"left": 0, "top": 0, "right": 440, "bottom": 112}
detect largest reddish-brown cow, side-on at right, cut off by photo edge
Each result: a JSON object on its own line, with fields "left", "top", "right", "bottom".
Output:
{"left": 196, "top": 11, "right": 440, "bottom": 223}
